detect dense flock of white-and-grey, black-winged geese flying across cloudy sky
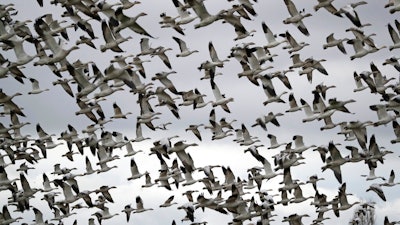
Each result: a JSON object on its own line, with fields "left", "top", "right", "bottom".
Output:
{"left": 0, "top": 0, "right": 400, "bottom": 225}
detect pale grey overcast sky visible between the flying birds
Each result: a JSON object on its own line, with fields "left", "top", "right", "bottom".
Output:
{"left": 0, "top": 0, "right": 400, "bottom": 224}
